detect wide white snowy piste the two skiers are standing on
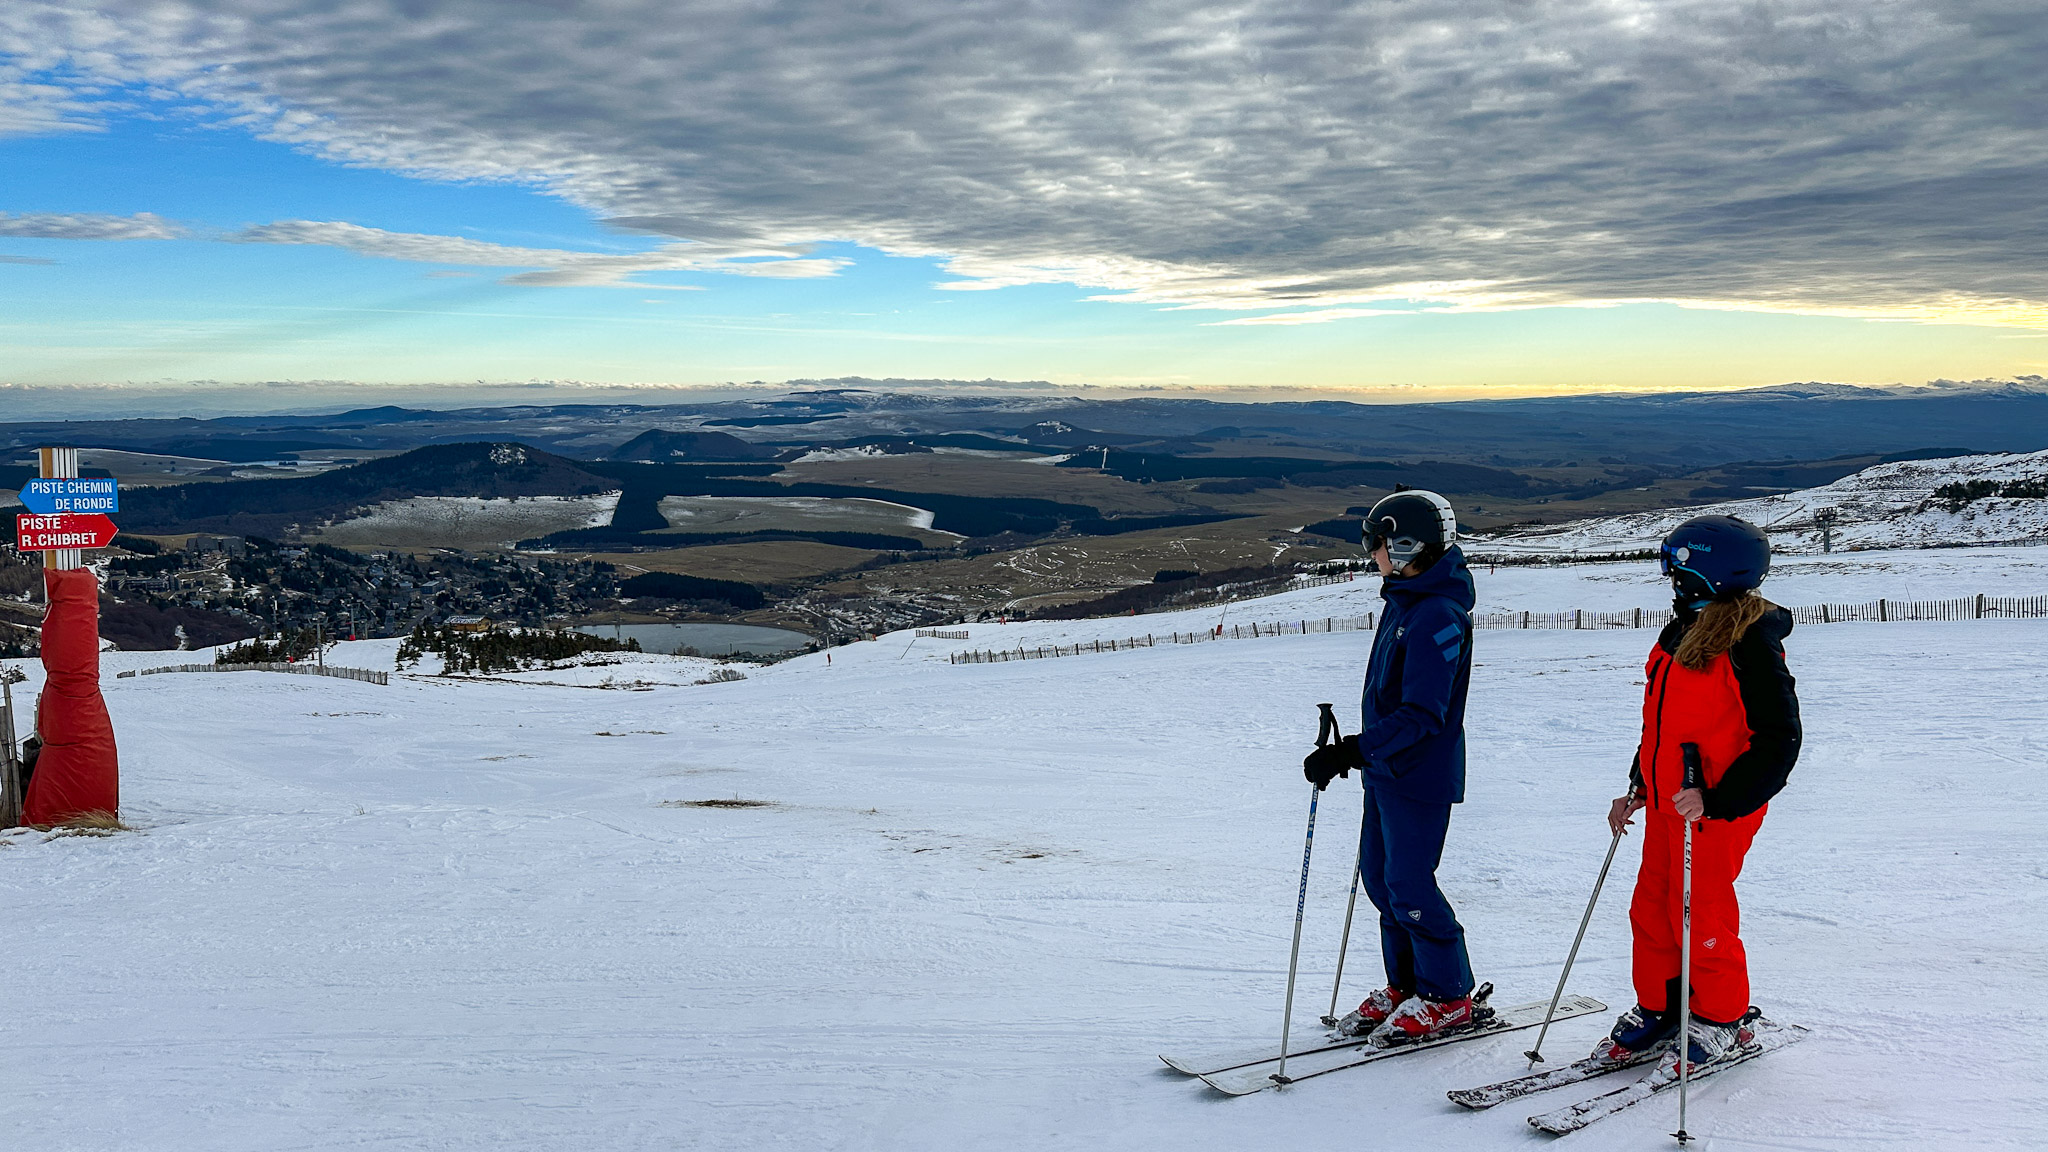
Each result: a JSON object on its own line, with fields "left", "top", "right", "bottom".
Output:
{"left": 0, "top": 549, "right": 2048, "bottom": 1150}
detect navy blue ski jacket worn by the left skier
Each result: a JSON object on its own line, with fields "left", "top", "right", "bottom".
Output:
{"left": 1358, "top": 545, "right": 1477, "bottom": 804}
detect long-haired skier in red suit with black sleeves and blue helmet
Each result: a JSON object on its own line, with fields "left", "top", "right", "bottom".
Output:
{"left": 1593, "top": 517, "right": 1800, "bottom": 1068}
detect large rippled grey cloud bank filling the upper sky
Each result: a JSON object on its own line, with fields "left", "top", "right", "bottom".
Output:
{"left": 0, "top": 0, "right": 2048, "bottom": 322}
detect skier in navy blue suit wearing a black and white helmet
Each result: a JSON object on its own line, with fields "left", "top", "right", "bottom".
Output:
{"left": 1303, "top": 490, "right": 1479, "bottom": 1045}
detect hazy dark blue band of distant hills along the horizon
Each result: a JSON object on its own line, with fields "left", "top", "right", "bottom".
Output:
{"left": 12, "top": 377, "right": 2048, "bottom": 471}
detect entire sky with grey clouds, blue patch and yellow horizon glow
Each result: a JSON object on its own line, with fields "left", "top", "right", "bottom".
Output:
{"left": 0, "top": 0, "right": 2048, "bottom": 396}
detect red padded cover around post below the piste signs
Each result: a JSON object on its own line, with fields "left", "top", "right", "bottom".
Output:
{"left": 23, "top": 568, "right": 121, "bottom": 826}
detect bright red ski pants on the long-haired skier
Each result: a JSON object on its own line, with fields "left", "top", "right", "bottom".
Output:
{"left": 1628, "top": 808, "right": 1763, "bottom": 1023}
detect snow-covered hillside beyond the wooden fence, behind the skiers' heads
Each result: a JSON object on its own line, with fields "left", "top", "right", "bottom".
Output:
{"left": 1470, "top": 451, "right": 2048, "bottom": 556}
